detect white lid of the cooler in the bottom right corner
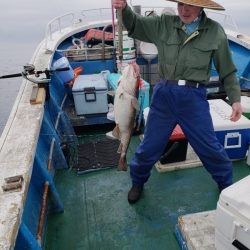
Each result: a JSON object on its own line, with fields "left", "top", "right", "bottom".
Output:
{"left": 219, "top": 175, "right": 250, "bottom": 219}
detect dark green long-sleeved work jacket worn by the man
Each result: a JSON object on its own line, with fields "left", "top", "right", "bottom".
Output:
{"left": 122, "top": 5, "right": 240, "bottom": 103}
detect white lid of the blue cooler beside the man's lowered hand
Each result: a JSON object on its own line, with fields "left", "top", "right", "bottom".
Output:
{"left": 208, "top": 99, "right": 250, "bottom": 131}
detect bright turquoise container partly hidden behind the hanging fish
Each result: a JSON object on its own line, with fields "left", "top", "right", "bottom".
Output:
{"left": 107, "top": 73, "right": 150, "bottom": 110}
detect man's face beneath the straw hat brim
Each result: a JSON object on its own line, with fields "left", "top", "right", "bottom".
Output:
{"left": 178, "top": 3, "right": 202, "bottom": 24}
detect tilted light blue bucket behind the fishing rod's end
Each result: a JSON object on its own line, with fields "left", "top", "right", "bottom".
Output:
{"left": 53, "top": 57, "right": 74, "bottom": 83}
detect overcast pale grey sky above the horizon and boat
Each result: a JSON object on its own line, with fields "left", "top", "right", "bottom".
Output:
{"left": 0, "top": 0, "right": 250, "bottom": 42}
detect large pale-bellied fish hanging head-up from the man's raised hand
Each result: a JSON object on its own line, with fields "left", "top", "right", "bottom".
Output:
{"left": 112, "top": 62, "right": 140, "bottom": 171}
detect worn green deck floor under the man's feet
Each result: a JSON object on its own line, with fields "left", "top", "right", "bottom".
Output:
{"left": 44, "top": 137, "right": 250, "bottom": 250}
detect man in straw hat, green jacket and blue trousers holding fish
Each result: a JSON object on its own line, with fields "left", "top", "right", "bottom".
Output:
{"left": 113, "top": 0, "right": 242, "bottom": 204}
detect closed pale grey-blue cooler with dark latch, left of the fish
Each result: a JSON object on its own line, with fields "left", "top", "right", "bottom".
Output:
{"left": 72, "top": 72, "right": 108, "bottom": 115}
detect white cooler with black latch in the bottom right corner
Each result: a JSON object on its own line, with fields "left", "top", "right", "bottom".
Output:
{"left": 215, "top": 175, "right": 250, "bottom": 250}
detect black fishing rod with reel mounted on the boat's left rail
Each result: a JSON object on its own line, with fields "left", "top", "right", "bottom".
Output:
{"left": 0, "top": 64, "right": 70, "bottom": 100}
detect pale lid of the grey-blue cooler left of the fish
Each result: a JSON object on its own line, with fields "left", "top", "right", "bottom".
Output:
{"left": 72, "top": 73, "right": 107, "bottom": 92}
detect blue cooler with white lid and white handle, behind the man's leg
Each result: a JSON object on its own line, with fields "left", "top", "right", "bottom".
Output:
{"left": 208, "top": 99, "right": 250, "bottom": 159}
